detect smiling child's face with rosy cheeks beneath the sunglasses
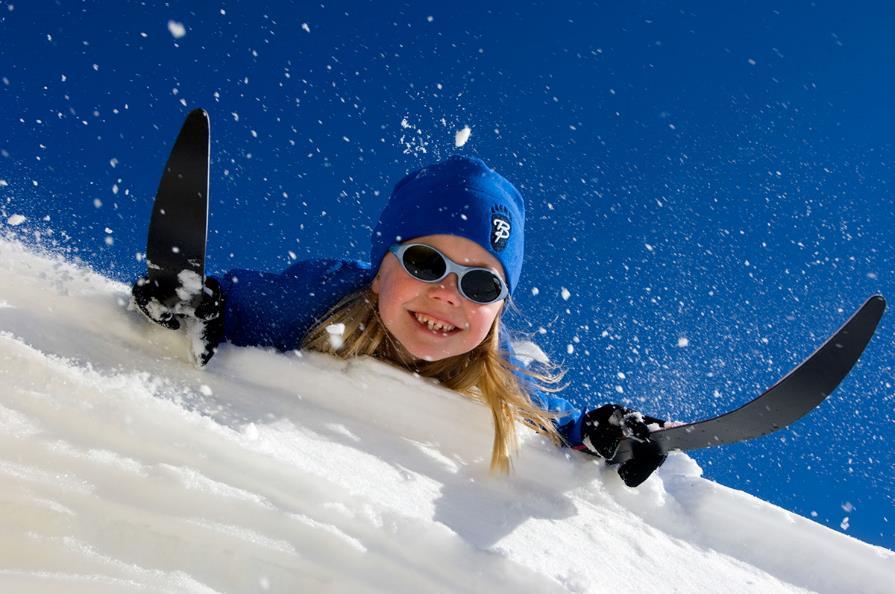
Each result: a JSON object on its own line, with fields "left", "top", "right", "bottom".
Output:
{"left": 372, "top": 235, "right": 506, "bottom": 361}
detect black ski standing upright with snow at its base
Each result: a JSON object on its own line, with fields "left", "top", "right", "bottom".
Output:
{"left": 146, "top": 109, "right": 210, "bottom": 306}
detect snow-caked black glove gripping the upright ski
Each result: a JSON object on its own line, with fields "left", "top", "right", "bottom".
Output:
{"left": 131, "top": 277, "right": 225, "bottom": 365}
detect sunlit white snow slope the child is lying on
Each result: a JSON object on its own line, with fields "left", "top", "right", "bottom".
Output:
{"left": 0, "top": 240, "right": 895, "bottom": 593}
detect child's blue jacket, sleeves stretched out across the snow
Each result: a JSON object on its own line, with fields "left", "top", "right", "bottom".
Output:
{"left": 210, "top": 259, "right": 585, "bottom": 447}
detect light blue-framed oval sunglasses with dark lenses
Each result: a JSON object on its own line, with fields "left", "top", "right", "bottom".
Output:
{"left": 388, "top": 243, "right": 509, "bottom": 304}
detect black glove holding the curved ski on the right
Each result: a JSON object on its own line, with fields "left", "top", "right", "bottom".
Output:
{"left": 582, "top": 404, "right": 667, "bottom": 487}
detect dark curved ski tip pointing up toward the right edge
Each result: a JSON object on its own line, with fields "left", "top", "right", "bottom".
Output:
{"left": 610, "top": 295, "right": 886, "bottom": 463}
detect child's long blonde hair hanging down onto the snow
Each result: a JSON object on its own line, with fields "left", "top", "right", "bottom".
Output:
{"left": 302, "top": 287, "right": 562, "bottom": 473}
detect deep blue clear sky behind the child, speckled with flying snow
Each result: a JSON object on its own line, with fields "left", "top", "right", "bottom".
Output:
{"left": 0, "top": 0, "right": 895, "bottom": 548}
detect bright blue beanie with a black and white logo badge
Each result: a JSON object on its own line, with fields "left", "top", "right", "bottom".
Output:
{"left": 370, "top": 155, "right": 525, "bottom": 292}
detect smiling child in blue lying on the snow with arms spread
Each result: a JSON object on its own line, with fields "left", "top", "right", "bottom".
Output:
{"left": 134, "top": 156, "right": 665, "bottom": 486}
